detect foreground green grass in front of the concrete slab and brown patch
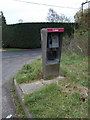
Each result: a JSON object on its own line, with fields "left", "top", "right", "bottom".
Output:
{"left": 25, "top": 84, "right": 88, "bottom": 118}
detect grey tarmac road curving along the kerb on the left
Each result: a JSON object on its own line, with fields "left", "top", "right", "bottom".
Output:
{"left": 0, "top": 49, "right": 41, "bottom": 118}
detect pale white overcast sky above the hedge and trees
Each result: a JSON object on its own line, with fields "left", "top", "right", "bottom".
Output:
{"left": 0, "top": 0, "right": 86, "bottom": 24}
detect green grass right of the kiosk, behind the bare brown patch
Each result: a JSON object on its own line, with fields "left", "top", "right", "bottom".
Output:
{"left": 60, "top": 54, "right": 88, "bottom": 87}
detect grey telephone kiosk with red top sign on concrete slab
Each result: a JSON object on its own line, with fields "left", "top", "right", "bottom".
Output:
{"left": 41, "top": 28, "right": 64, "bottom": 79}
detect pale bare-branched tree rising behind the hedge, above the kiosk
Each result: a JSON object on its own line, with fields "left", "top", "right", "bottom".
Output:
{"left": 47, "top": 8, "right": 70, "bottom": 22}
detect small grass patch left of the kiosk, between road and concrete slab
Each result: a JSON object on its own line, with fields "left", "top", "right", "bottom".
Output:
{"left": 15, "top": 58, "right": 42, "bottom": 84}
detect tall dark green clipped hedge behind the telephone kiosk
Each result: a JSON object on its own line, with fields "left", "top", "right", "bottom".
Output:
{"left": 2, "top": 23, "right": 75, "bottom": 48}
